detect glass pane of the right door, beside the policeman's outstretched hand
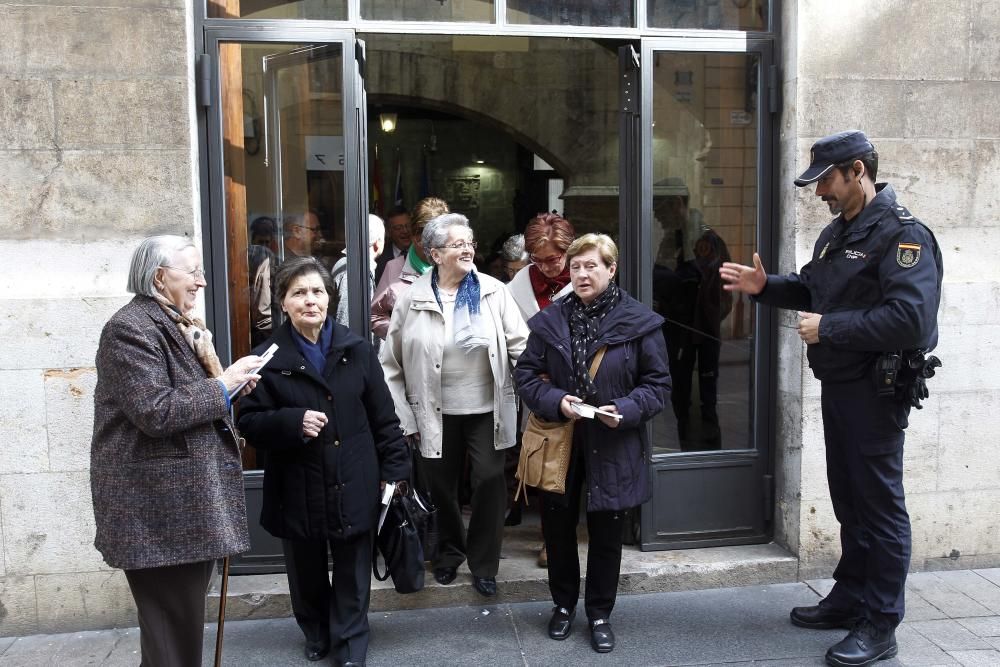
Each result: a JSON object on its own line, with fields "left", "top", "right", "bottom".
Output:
{"left": 650, "top": 52, "right": 759, "bottom": 453}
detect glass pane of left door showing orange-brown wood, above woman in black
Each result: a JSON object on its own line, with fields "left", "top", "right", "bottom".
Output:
{"left": 219, "top": 43, "right": 345, "bottom": 469}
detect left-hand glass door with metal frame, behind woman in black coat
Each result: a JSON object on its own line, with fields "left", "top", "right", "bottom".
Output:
{"left": 202, "top": 26, "right": 371, "bottom": 572}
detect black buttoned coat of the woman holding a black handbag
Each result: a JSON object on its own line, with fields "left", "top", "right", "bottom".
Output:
{"left": 239, "top": 321, "right": 410, "bottom": 540}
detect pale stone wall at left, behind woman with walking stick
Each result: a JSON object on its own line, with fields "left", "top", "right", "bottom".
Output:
{"left": 0, "top": 0, "right": 200, "bottom": 636}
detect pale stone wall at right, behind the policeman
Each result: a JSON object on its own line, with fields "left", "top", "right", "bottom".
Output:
{"left": 769, "top": 0, "right": 1000, "bottom": 578}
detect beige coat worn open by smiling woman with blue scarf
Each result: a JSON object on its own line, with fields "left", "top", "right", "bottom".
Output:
{"left": 379, "top": 271, "right": 528, "bottom": 459}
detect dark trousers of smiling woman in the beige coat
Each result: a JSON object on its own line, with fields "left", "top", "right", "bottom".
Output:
{"left": 418, "top": 412, "right": 507, "bottom": 577}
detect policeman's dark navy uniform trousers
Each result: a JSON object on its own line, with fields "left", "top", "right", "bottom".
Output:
{"left": 822, "top": 378, "right": 910, "bottom": 628}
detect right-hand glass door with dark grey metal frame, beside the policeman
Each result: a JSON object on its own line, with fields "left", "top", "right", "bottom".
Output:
{"left": 636, "top": 40, "right": 773, "bottom": 549}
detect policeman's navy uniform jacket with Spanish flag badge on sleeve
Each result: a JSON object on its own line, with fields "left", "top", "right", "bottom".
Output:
{"left": 757, "top": 183, "right": 944, "bottom": 382}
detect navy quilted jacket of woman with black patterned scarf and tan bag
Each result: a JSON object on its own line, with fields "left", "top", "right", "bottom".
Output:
{"left": 514, "top": 291, "right": 670, "bottom": 512}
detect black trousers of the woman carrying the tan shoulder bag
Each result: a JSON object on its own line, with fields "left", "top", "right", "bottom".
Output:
{"left": 541, "top": 444, "right": 625, "bottom": 621}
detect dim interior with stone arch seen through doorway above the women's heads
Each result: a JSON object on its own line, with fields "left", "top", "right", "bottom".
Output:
{"left": 360, "top": 34, "right": 619, "bottom": 260}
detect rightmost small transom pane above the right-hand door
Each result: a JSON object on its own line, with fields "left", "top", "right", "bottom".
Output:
{"left": 646, "top": 0, "right": 769, "bottom": 30}
